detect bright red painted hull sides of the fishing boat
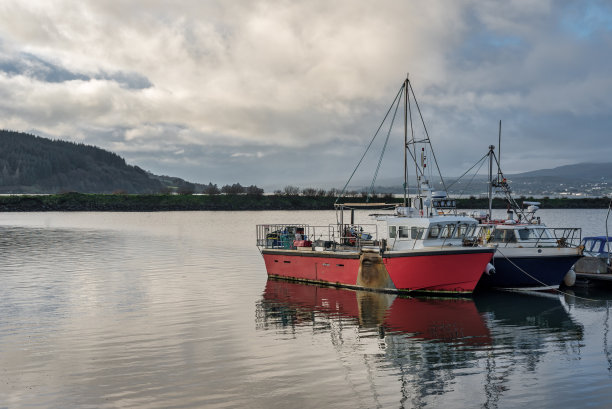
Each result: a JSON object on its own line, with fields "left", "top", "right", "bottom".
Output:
{"left": 262, "top": 248, "right": 494, "bottom": 293}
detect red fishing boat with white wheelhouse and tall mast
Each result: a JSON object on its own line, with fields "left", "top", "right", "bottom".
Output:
{"left": 257, "top": 79, "right": 495, "bottom": 294}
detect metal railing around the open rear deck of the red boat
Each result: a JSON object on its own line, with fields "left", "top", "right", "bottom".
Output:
{"left": 256, "top": 223, "right": 379, "bottom": 251}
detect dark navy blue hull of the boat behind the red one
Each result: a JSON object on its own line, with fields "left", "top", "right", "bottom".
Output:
{"left": 476, "top": 254, "right": 580, "bottom": 290}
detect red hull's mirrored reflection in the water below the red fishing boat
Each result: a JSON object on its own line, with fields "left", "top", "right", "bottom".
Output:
{"left": 260, "top": 279, "right": 491, "bottom": 344}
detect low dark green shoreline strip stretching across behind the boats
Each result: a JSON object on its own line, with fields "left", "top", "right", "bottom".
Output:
{"left": 0, "top": 193, "right": 610, "bottom": 212}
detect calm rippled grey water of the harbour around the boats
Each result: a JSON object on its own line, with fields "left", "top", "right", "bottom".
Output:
{"left": 0, "top": 210, "right": 612, "bottom": 408}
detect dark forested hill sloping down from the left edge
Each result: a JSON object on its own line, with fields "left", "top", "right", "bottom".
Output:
{"left": 0, "top": 130, "right": 195, "bottom": 193}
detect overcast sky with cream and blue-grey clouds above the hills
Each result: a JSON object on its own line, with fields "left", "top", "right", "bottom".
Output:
{"left": 0, "top": 0, "right": 612, "bottom": 186}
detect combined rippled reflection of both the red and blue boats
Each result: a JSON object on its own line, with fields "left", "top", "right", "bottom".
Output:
{"left": 256, "top": 279, "right": 583, "bottom": 408}
